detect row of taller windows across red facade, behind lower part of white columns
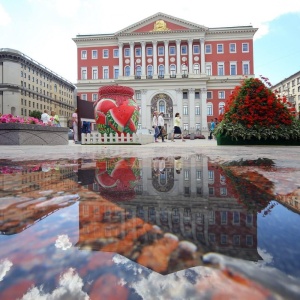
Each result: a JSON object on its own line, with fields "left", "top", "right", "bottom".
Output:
{"left": 81, "top": 61, "right": 250, "bottom": 80}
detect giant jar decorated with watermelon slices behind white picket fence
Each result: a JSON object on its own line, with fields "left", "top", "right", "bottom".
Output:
{"left": 94, "top": 85, "right": 139, "bottom": 134}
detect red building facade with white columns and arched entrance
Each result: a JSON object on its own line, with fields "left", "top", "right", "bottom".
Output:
{"left": 73, "top": 13, "right": 257, "bottom": 133}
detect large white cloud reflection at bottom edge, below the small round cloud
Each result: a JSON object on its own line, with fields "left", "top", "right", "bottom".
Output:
{"left": 22, "top": 268, "right": 90, "bottom": 300}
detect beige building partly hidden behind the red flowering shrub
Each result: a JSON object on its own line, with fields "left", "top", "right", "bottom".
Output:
{"left": 271, "top": 71, "right": 300, "bottom": 114}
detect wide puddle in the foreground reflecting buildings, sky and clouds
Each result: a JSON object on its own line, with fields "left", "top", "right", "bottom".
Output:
{"left": 0, "top": 155, "right": 300, "bottom": 299}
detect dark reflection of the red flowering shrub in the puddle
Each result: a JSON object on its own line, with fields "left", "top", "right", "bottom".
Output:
{"left": 223, "top": 158, "right": 274, "bottom": 212}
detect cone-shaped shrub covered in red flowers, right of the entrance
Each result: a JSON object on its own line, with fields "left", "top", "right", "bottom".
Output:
{"left": 214, "top": 78, "right": 300, "bottom": 140}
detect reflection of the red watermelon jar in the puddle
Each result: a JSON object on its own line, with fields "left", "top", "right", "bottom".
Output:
{"left": 95, "top": 157, "right": 140, "bottom": 200}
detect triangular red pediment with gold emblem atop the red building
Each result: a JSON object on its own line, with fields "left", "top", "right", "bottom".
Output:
{"left": 116, "top": 12, "right": 208, "bottom": 35}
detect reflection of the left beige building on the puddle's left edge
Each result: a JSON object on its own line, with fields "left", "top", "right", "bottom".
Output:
{"left": 0, "top": 166, "right": 78, "bottom": 234}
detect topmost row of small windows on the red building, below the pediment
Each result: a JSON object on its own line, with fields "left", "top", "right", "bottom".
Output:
{"left": 81, "top": 43, "right": 249, "bottom": 59}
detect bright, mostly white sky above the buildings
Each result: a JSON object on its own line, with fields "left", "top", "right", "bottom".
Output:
{"left": 0, "top": 0, "right": 300, "bottom": 84}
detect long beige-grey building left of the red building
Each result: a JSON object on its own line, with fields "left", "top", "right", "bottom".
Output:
{"left": 0, "top": 48, "right": 76, "bottom": 125}
